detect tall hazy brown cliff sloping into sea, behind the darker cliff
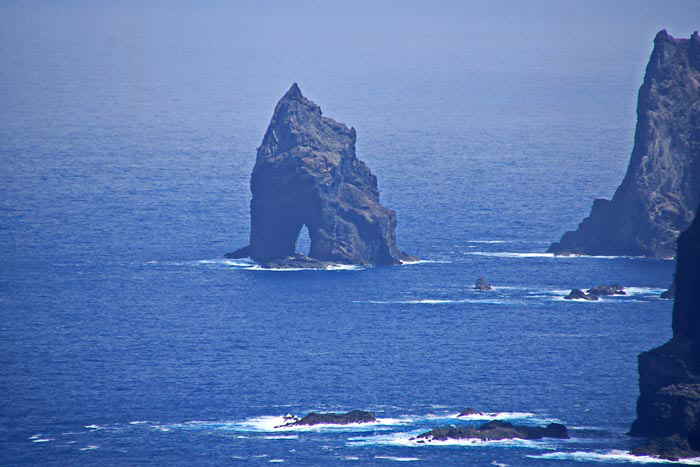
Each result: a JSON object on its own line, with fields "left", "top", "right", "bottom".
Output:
{"left": 548, "top": 31, "right": 700, "bottom": 257}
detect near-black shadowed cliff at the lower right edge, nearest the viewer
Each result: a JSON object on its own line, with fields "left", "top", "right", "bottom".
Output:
{"left": 630, "top": 202, "right": 700, "bottom": 458}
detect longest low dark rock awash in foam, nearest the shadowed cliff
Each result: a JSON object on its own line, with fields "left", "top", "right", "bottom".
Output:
{"left": 412, "top": 420, "right": 569, "bottom": 441}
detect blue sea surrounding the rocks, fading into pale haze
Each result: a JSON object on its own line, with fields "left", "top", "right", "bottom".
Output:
{"left": 0, "top": 1, "right": 700, "bottom": 466}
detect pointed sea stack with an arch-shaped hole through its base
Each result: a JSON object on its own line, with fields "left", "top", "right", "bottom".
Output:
{"left": 227, "top": 83, "right": 415, "bottom": 267}
